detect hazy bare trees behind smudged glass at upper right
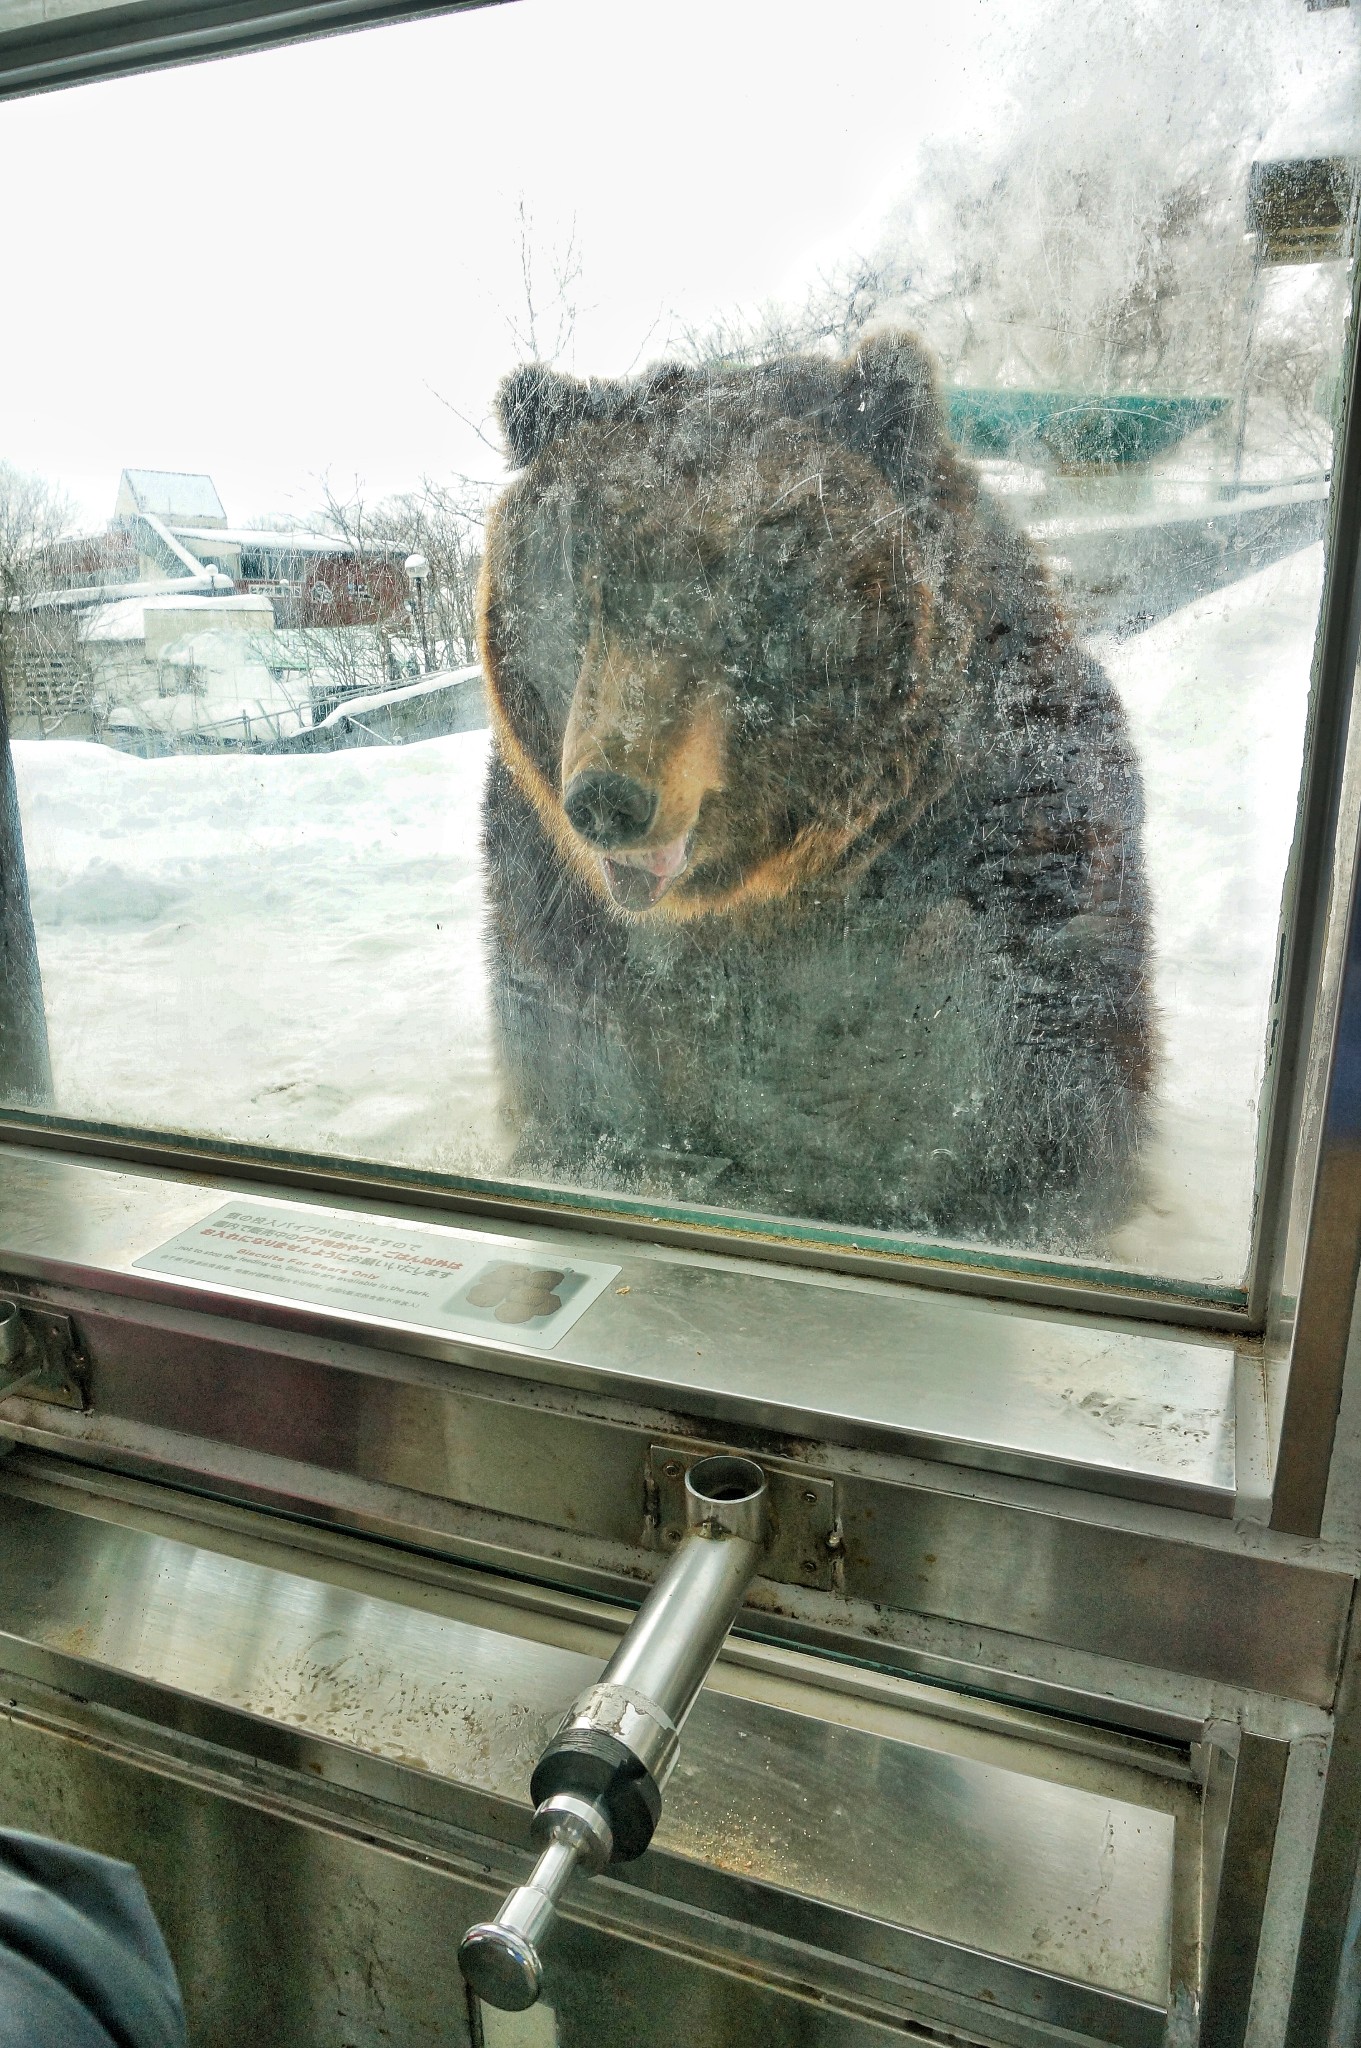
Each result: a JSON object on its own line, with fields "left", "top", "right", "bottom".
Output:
{"left": 667, "top": 0, "right": 1349, "bottom": 461}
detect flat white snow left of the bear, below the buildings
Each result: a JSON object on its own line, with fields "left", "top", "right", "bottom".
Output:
{"left": 14, "top": 731, "right": 501, "bottom": 1171}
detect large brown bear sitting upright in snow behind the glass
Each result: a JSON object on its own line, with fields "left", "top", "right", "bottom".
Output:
{"left": 481, "top": 334, "right": 1152, "bottom": 1247}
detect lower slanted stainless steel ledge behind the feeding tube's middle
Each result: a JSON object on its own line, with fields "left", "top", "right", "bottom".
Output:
{"left": 0, "top": 1473, "right": 1211, "bottom": 2048}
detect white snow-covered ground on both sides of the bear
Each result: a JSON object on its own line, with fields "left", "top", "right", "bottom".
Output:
{"left": 14, "top": 547, "right": 1322, "bottom": 1280}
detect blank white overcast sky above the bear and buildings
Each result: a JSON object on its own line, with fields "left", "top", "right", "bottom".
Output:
{"left": 0, "top": 0, "right": 1023, "bottom": 524}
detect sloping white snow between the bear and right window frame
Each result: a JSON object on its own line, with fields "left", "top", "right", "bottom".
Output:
{"left": 1097, "top": 545, "right": 1324, "bottom": 1282}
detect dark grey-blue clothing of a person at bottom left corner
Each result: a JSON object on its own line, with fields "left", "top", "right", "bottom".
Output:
{"left": 0, "top": 1829, "right": 184, "bottom": 2048}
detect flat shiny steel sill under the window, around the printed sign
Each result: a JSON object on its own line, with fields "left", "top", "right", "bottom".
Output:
{"left": 0, "top": 1149, "right": 1234, "bottom": 1516}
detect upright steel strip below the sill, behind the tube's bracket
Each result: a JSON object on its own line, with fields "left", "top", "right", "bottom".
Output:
{"left": 0, "top": 1290, "right": 1353, "bottom": 1706}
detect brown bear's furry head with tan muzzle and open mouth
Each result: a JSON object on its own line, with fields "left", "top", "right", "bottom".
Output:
{"left": 481, "top": 334, "right": 974, "bottom": 918}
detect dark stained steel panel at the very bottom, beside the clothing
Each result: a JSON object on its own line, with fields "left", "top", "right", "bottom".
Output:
{"left": 0, "top": 1712, "right": 953, "bottom": 2048}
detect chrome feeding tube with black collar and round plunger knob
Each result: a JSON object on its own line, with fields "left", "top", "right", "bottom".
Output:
{"left": 458, "top": 1456, "right": 770, "bottom": 2011}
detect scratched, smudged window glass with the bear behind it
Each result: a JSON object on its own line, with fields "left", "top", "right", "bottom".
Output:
{"left": 0, "top": 0, "right": 1361, "bottom": 1290}
